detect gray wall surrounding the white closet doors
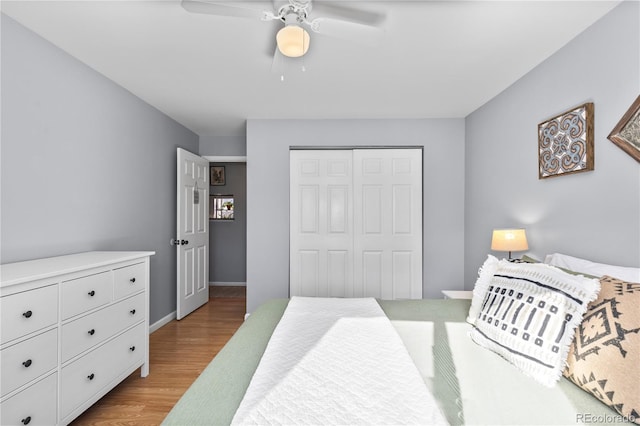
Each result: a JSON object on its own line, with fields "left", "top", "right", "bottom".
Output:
{"left": 247, "top": 119, "right": 465, "bottom": 312}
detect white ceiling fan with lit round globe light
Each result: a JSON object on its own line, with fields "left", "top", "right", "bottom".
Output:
{"left": 181, "top": 0, "right": 385, "bottom": 58}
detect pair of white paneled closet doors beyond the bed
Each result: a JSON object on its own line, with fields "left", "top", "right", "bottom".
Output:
{"left": 290, "top": 149, "right": 422, "bottom": 299}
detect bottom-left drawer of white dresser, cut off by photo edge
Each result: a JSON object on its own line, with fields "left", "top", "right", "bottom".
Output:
{"left": 0, "top": 373, "right": 58, "bottom": 426}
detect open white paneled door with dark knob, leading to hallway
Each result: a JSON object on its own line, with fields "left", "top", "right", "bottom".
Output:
{"left": 176, "top": 148, "right": 209, "bottom": 319}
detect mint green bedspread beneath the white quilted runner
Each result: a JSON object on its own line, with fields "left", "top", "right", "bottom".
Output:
{"left": 163, "top": 299, "right": 628, "bottom": 426}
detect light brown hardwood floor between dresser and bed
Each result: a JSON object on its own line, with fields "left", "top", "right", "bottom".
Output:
{"left": 71, "top": 287, "right": 246, "bottom": 426}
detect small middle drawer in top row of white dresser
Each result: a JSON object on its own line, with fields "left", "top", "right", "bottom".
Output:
{"left": 62, "top": 271, "right": 113, "bottom": 320}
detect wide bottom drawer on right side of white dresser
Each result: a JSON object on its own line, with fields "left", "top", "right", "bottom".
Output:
{"left": 60, "top": 324, "right": 145, "bottom": 418}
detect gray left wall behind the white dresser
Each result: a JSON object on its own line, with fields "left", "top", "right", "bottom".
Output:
{"left": 0, "top": 15, "right": 198, "bottom": 323}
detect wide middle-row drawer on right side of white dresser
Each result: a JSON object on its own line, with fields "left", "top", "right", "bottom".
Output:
{"left": 61, "top": 293, "right": 146, "bottom": 362}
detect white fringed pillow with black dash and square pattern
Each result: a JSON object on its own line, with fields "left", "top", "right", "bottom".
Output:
{"left": 471, "top": 260, "right": 600, "bottom": 387}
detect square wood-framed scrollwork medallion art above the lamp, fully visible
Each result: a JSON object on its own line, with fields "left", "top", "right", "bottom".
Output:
{"left": 538, "top": 102, "right": 594, "bottom": 179}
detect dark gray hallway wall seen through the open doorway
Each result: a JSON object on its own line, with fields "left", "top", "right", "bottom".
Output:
{"left": 209, "top": 163, "right": 247, "bottom": 285}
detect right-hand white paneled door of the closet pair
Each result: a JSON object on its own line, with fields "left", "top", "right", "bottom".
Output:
{"left": 353, "top": 149, "right": 422, "bottom": 299}
